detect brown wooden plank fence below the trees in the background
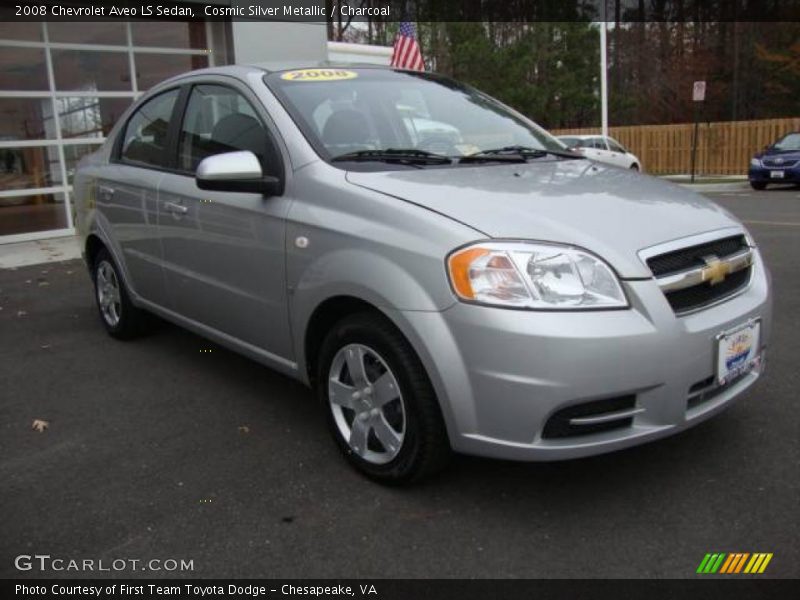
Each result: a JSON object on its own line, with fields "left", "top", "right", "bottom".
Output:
{"left": 551, "top": 117, "right": 800, "bottom": 175}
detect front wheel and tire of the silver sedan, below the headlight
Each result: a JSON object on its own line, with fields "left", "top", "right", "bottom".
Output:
{"left": 316, "top": 313, "right": 451, "bottom": 484}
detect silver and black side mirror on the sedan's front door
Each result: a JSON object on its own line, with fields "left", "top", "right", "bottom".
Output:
{"left": 195, "top": 150, "right": 283, "bottom": 196}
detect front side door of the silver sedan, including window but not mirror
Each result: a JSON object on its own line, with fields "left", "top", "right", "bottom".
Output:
{"left": 158, "top": 80, "right": 292, "bottom": 359}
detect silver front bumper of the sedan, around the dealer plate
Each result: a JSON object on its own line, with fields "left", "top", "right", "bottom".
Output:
{"left": 402, "top": 248, "right": 772, "bottom": 460}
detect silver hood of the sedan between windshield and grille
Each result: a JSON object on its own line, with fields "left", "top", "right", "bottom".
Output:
{"left": 347, "top": 159, "right": 740, "bottom": 278}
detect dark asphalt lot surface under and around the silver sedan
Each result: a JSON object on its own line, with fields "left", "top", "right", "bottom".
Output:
{"left": 0, "top": 188, "right": 800, "bottom": 578}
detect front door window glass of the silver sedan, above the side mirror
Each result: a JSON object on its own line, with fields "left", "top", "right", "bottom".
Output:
{"left": 178, "top": 85, "right": 271, "bottom": 172}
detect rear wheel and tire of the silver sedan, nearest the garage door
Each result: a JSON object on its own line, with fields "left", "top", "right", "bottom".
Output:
{"left": 92, "top": 248, "right": 146, "bottom": 340}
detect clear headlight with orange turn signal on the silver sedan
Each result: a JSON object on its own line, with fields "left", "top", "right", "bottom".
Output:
{"left": 447, "top": 242, "right": 628, "bottom": 310}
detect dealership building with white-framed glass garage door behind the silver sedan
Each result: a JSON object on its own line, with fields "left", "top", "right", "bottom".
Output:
{"left": 0, "top": 15, "right": 390, "bottom": 243}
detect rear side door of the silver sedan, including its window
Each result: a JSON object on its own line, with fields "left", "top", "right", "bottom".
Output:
{"left": 96, "top": 88, "right": 180, "bottom": 305}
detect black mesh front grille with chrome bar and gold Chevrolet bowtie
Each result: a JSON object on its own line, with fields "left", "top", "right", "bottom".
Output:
{"left": 647, "top": 234, "right": 753, "bottom": 314}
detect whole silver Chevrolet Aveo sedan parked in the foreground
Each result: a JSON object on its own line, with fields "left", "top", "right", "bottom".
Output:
{"left": 75, "top": 66, "right": 771, "bottom": 482}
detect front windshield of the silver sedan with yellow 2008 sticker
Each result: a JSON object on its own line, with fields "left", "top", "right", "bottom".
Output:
{"left": 264, "top": 68, "right": 566, "bottom": 164}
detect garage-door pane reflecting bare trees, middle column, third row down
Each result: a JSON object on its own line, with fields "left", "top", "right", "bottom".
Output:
{"left": 56, "top": 97, "right": 133, "bottom": 138}
